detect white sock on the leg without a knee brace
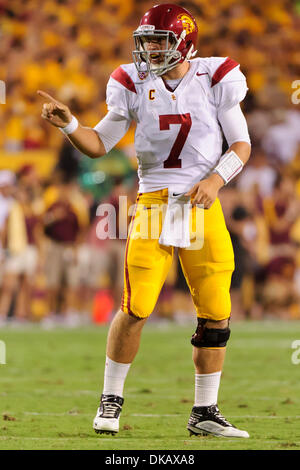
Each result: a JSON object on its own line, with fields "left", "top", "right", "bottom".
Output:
{"left": 103, "top": 356, "right": 131, "bottom": 397}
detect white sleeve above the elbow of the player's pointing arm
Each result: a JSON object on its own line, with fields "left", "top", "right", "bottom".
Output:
{"left": 94, "top": 111, "right": 131, "bottom": 153}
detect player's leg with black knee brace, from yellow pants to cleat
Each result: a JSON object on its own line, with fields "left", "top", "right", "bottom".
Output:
{"left": 179, "top": 200, "right": 248, "bottom": 437}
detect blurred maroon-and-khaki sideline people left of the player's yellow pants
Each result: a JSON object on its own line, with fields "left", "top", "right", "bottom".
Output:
{"left": 0, "top": 165, "right": 136, "bottom": 326}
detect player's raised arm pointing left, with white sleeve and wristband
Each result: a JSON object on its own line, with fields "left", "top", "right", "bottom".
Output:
{"left": 38, "top": 91, "right": 130, "bottom": 158}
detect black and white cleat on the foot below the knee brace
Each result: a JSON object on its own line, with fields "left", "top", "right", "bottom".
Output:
{"left": 187, "top": 405, "right": 249, "bottom": 437}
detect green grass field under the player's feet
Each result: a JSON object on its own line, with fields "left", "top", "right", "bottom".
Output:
{"left": 0, "top": 322, "right": 300, "bottom": 451}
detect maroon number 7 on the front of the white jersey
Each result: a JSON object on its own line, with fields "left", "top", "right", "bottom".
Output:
{"left": 159, "top": 113, "right": 192, "bottom": 168}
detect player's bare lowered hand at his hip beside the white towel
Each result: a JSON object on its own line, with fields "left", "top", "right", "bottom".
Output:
{"left": 185, "top": 173, "right": 224, "bottom": 209}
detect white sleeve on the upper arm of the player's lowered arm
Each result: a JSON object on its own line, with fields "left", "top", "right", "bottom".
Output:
{"left": 218, "top": 104, "right": 251, "bottom": 147}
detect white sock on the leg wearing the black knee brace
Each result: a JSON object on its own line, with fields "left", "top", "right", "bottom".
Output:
{"left": 194, "top": 371, "right": 221, "bottom": 406}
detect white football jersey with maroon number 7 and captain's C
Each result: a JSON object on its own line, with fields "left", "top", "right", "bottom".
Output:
{"left": 107, "top": 57, "right": 248, "bottom": 192}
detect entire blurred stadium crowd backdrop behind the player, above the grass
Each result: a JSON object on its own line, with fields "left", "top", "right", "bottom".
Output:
{"left": 0, "top": 0, "right": 300, "bottom": 327}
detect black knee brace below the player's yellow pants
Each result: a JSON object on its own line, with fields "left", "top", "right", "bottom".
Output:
{"left": 191, "top": 318, "right": 230, "bottom": 348}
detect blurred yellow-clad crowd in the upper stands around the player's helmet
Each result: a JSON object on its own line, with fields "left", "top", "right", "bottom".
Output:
{"left": 0, "top": 0, "right": 300, "bottom": 151}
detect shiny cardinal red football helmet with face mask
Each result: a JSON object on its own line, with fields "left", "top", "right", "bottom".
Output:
{"left": 132, "top": 3, "right": 198, "bottom": 76}
